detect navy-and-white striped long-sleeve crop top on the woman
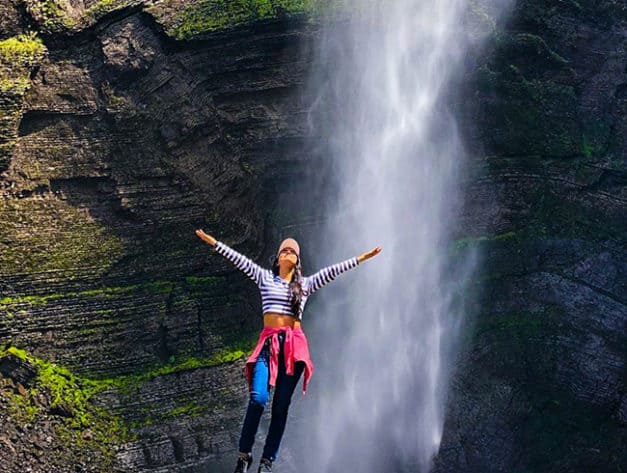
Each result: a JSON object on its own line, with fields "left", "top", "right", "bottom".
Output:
{"left": 215, "top": 242, "right": 359, "bottom": 318}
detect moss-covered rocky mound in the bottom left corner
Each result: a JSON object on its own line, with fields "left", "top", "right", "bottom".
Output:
{"left": 0, "top": 345, "right": 129, "bottom": 473}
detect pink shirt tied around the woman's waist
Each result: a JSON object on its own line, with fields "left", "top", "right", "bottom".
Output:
{"left": 245, "top": 326, "right": 313, "bottom": 394}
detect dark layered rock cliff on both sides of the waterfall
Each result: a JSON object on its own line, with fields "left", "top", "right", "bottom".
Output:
{"left": 0, "top": 0, "right": 627, "bottom": 472}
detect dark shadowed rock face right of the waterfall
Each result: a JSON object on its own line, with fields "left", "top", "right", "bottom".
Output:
{"left": 436, "top": 0, "right": 627, "bottom": 472}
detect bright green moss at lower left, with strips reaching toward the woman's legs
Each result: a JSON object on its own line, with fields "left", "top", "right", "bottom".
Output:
{"left": 0, "top": 334, "right": 256, "bottom": 452}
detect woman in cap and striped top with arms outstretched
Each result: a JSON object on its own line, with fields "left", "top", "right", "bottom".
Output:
{"left": 196, "top": 230, "right": 381, "bottom": 473}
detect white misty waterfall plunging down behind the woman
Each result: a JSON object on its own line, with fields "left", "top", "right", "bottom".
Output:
{"left": 287, "top": 0, "right": 510, "bottom": 473}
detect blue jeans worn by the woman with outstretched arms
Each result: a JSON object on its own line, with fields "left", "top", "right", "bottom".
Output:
{"left": 239, "top": 333, "right": 305, "bottom": 461}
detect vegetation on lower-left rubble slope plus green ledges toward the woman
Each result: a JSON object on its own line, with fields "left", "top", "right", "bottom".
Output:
{"left": 0, "top": 336, "right": 253, "bottom": 473}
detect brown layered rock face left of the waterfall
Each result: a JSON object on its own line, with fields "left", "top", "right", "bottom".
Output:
{"left": 0, "top": 2, "right": 322, "bottom": 471}
